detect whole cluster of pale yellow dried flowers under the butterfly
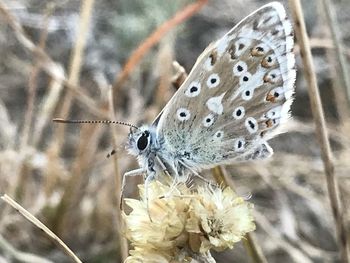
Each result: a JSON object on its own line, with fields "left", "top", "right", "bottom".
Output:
{"left": 123, "top": 181, "right": 255, "bottom": 263}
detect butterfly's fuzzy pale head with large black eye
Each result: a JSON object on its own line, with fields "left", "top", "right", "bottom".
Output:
{"left": 127, "top": 126, "right": 155, "bottom": 156}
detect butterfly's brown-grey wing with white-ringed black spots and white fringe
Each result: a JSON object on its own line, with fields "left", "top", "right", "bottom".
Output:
{"left": 157, "top": 2, "right": 296, "bottom": 170}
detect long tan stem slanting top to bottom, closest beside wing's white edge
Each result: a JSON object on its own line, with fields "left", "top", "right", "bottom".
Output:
{"left": 289, "top": 0, "right": 349, "bottom": 262}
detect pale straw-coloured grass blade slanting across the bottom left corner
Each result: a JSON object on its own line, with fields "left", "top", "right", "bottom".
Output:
{"left": 1, "top": 195, "right": 82, "bottom": 263}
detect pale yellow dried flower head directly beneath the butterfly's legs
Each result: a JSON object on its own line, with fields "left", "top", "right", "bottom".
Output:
{"left": 123, "top": 181, "right": 191, "bottom": 250}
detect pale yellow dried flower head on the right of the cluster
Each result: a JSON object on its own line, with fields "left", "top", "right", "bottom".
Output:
{"left": 186, "top": 187, "right": 255, "bottom": 253}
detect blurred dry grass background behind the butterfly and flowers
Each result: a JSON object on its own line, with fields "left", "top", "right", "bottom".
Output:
{"left": 0, "top": 0, "right": 350, "bottom": 263}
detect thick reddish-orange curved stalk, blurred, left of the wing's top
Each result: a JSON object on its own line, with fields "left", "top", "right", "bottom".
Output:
{"left": 113, "top": 0, "right": 208, "bottom": 91}
